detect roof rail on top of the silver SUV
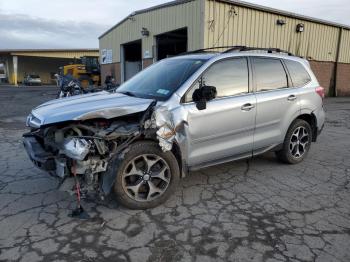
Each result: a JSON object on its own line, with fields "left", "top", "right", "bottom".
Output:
{"left": 179, "top": 45, "right": 294, "bottom": 56}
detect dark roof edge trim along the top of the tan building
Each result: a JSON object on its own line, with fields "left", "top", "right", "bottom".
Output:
{"left": 98, "top": 0, "right": 350, "bottom": 39}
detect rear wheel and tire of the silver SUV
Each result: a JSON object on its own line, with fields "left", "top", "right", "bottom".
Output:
{"left": 276, "top": 119, "right": 312, "bottom": 164}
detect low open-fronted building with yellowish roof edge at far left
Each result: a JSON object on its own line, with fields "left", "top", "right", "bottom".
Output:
{"left": 0, "top": 49, "right": 99, "bottom": 85}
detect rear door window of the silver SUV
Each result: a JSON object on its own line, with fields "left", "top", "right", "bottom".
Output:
{"left": 253, "top": 58, "right": 288, "bottom": 91}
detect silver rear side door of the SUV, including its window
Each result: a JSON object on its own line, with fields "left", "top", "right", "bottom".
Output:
{"left": 251, "top": 57, "right": 300, "bottom": 153}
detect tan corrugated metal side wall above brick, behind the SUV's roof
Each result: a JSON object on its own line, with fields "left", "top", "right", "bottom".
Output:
{"left": 204, "top": 0, "right": 344, "bottom": 61}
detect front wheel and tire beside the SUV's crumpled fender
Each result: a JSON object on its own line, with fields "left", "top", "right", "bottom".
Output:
{"left": 114, "top": 141, "right": 180, "bottom": 209}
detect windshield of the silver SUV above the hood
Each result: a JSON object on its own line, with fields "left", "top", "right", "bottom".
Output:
{"left": 117, "top": 58, "right": 206, "bottom": 101}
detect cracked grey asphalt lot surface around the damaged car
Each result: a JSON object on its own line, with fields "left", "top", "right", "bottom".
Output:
{"left": 0, "top": 86, "right": 350, "bottom": 262}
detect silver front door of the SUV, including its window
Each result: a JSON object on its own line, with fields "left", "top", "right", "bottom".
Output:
{"left": 184, "top": 58, "right": 256, "bottom": 166}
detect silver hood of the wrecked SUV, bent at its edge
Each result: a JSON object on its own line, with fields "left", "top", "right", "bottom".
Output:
{"left": 28, "top": 91, "right": 153, "bottom": 127}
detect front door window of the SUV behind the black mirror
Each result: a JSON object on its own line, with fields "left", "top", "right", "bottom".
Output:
{"left": 185, "top": 58, "right": 249, "bottom": 102}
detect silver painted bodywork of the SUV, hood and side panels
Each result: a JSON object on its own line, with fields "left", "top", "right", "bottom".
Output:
{"left": 27, "top": 52, "right": 324, "bottom": 170}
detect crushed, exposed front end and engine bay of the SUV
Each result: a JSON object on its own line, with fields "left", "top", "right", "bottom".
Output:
{"left": 24, "top": 101, "right": 176, "bottom": 201}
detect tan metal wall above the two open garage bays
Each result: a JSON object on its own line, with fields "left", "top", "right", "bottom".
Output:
{"left": 99, "top": 0, "right": 204, "bottom": 63}
